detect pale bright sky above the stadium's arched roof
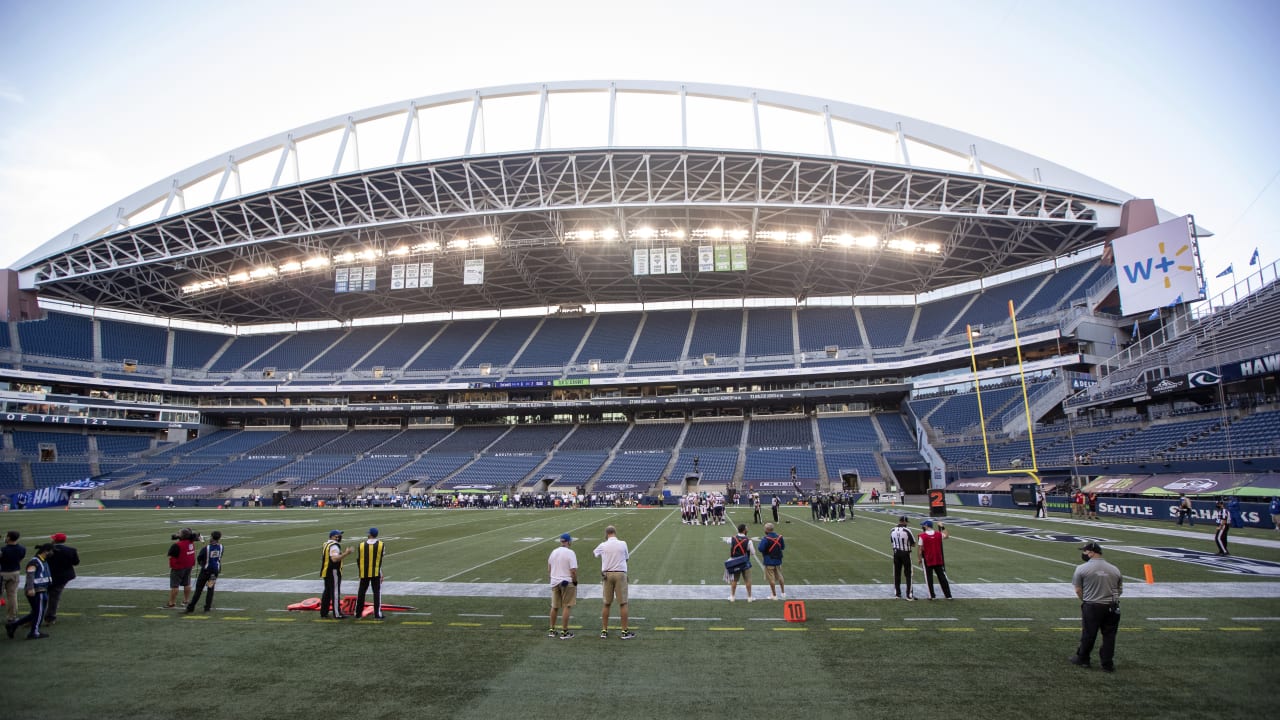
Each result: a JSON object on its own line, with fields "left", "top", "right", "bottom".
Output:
{"left": 0, "top": 0, "right": 1280, "bottom": 295}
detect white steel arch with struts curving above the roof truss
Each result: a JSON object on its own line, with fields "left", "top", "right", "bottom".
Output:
{"left": 14, "top": 79, "right": 1133, "bottom": 269}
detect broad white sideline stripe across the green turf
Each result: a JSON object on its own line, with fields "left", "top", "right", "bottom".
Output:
{"left": 70, "top": 575, "right": 1280, "bottom": 602}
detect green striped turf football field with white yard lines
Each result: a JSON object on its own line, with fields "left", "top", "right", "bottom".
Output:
{"left": 0, "top": 505, "right": 1280, "bottom": 720}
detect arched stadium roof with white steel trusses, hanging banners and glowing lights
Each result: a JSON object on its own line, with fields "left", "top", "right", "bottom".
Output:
{"left": 7, "top": 81, "right": 1162, "bottom": 325}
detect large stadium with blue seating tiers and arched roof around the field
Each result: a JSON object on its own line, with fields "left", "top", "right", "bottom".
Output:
{"left": 0, "top": 81, "right": 1280, "bottom": 716}
